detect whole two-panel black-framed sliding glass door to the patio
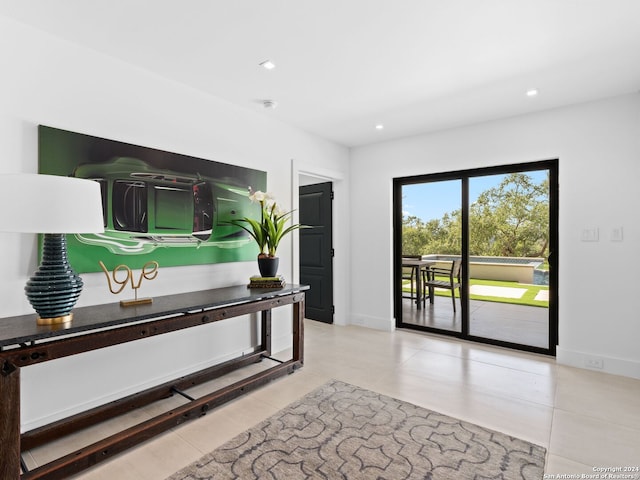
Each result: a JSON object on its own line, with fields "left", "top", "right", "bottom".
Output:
{"left": 394, "top": 160, "right": 557, "bottom": 354}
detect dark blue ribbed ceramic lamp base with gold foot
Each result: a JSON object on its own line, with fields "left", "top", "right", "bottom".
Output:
{"left": 24, "top": 233, "right": 83, "bottom": 325}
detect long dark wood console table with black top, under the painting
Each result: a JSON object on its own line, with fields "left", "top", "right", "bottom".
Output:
{"left": 0, "top": 285, "right": 309, "bottom": 480}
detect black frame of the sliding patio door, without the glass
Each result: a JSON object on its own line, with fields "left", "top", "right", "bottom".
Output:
{"left": 393, "top": 158, "right": 559, "bottom": 356}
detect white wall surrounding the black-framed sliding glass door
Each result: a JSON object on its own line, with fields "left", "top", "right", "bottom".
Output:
{"left": 350, "top": 94, "right": 640, "bottom": 378}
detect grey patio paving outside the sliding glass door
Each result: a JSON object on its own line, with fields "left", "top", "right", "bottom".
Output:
{"left": 402, "top": 296, "right": 549, "bottom": 348}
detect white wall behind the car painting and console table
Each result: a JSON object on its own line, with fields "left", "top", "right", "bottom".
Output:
{"left": 0, "top": 16, "right": 348, "bottom": 429}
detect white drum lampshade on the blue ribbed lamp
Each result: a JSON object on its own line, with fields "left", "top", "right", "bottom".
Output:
{"left": 0, "top": 173, "right": 104, "bottom": 233}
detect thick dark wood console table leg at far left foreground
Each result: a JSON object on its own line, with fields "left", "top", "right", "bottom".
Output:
{"left": 0, "top": 360, "right": 20, "bottom": 479}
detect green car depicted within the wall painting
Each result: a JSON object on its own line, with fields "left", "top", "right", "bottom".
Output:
{"left": 73, "top": 157, "right": 259, "bottom": 255}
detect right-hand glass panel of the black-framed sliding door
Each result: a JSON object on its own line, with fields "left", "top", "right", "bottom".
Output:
{"left": 468, "top": 169, "right": 550, "bottom": 350}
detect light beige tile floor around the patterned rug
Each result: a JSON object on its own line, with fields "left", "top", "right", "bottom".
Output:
{"left": 27, "top": 320, "right": 640, "bottom": 480}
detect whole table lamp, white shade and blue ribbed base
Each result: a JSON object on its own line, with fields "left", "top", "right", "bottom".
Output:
{"left": 0, "top": 173, "right": 104, "bottom": 325}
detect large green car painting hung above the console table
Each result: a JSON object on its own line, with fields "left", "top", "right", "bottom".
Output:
{"left": 38, "top": 125, "right": 267, "bottom": 273}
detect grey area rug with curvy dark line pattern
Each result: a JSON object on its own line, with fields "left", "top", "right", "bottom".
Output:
{"left": 167, "top": 381, "right": 545, "bottom": 480}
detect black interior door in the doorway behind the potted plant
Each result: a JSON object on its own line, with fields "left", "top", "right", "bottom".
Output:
{"left": 300, "top": 182, "right": 333, "bottom": 323}
